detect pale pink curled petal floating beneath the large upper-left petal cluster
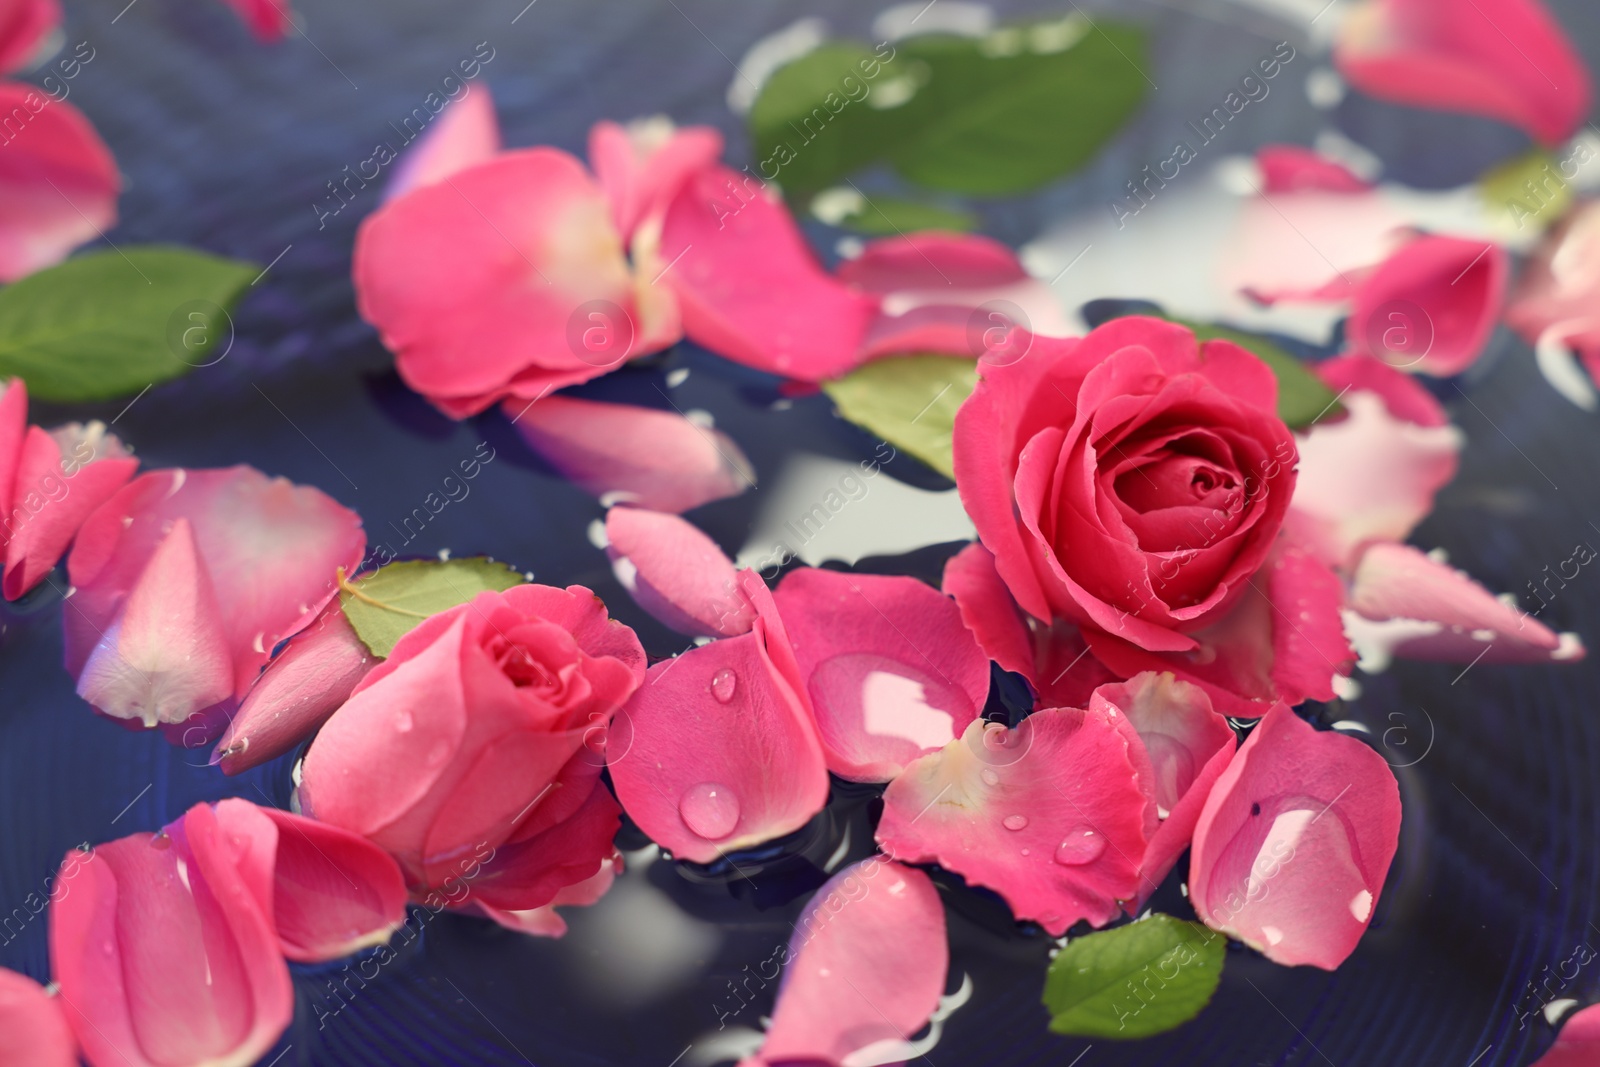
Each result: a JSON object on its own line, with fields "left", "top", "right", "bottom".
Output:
{"left": 506, "top": 397, "right": 755, "bottom": 514}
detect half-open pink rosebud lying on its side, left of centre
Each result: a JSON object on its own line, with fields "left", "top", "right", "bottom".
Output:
{"left": 301, "top": 585, "right": 645, "bottom": 910}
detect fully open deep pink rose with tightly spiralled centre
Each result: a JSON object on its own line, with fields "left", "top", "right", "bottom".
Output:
{"left": 954, "top": 317, "right": 1296, "bottom": 651}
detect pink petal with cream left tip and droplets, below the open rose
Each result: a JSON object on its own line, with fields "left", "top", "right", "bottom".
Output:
{"left": 877, "top": 709, "right": 1147, "bottom": 936}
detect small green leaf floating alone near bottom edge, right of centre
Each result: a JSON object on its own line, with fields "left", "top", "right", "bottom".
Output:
{"left": 1045, "top": 915, "right": 1227, "bottom": 1038}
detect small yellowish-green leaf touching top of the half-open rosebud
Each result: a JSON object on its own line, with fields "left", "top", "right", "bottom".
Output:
{"left": 339, "top": 557, "right": 523, "bottom": 657}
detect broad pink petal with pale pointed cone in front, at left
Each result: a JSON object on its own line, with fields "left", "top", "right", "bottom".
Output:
{"left": 64, "top": 467, "right": 366, "bottom": 747}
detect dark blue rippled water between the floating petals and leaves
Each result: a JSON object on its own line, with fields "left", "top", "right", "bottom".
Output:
{"left": 0, "top": 0, "right": 1600, "bottom": 1067}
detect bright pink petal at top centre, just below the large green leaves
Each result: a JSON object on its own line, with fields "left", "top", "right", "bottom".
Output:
{"left": 661, "top": 166, "right": 878, "bottom": 381}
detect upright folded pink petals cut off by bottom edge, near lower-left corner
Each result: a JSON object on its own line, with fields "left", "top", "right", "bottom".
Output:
{"left": 50, "top": 805, "right": 294, "bottom": 1067}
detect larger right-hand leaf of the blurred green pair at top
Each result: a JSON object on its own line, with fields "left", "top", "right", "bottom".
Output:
{"left": 888, "top": 13, "right": 1150, "bottom": 197}
